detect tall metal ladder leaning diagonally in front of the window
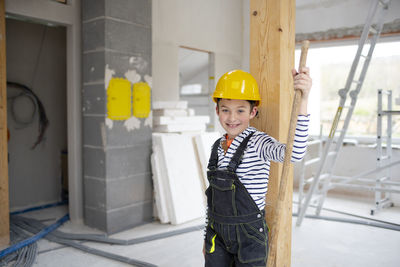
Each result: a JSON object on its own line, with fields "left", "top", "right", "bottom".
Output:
{"left": 296, "top": 0, "right": 390, "bottom": 226}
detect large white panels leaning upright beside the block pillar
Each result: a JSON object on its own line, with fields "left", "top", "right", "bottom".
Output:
{"left": 152, "top": 133, "right": 206, "bottom": 224}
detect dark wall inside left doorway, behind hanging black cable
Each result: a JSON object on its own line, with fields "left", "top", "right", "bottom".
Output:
{"left": 6, "top": 19, "right": 67, "bottom": 210}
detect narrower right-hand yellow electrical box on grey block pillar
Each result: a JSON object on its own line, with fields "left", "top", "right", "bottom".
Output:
{"left": 132, "top": 82, "right": 151, "bottom": 118}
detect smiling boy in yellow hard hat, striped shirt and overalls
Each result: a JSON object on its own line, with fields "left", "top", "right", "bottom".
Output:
{"left": 203, "top": 68, "right": 312, "bottom": 267}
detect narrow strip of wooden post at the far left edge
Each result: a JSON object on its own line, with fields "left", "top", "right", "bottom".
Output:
{"left": 0, "top": 0, "right": 10, "bottom": 248}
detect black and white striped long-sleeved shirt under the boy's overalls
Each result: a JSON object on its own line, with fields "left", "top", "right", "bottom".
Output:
{"left": 212, "top": 115, "right": 310, "bottom": 210}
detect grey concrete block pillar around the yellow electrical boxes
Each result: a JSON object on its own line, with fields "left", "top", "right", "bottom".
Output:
{"left": 82, "top": 0, "right": 153, "bottom": 233}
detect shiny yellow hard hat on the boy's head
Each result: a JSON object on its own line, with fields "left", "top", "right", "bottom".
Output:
{"left": 213, "top": 70, "right": 261, "bottom": 106}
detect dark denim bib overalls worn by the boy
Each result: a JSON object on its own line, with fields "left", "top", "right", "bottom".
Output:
{"left": 205, "top": 133, "right": 268, "bottom": 267}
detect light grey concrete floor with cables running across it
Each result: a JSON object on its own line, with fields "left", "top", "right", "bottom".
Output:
{"left": 3, "top": 196, "right": 400, "bottom": 267}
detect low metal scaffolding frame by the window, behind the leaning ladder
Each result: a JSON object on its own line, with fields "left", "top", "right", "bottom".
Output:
{"left": 298, "top": 89, "right": 400, "bottom": 220}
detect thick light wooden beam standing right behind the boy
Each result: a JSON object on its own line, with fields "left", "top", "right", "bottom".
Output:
{"left": 250, "top": 0, "right": 295, "bottom": 267}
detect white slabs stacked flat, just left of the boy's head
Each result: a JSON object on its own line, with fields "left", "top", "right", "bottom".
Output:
{"left": 153, "top": 101, "right": 210, "bottom": 133}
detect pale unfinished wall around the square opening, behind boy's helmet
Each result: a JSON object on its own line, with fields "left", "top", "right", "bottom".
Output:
{"left": 153, "top": 0, "right": 242, "bottom": 101}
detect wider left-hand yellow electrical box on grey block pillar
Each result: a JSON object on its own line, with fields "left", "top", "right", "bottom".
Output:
{"left": 107, "top": 78, "right": 132, "bottom": 120}
